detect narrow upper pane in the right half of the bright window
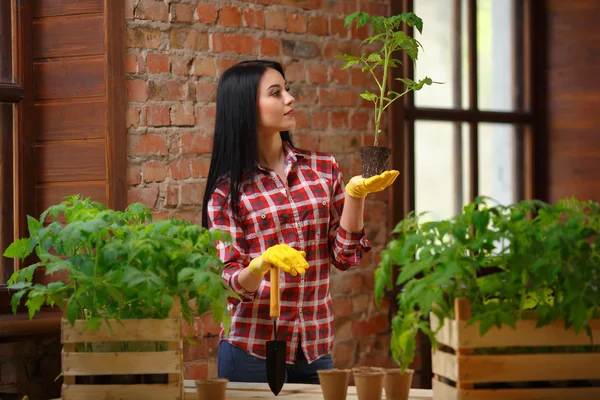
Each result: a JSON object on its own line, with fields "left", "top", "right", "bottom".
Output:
{"left": 477, "top": 0, "right": 515, "bottom": 111}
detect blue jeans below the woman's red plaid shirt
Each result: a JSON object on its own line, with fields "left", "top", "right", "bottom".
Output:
{"left": 218, "top": 340, "right": 333, "bottom": 385}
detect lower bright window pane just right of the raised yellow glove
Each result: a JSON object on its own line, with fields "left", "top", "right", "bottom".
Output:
{"left": 415, "top": 121, "right": 469, "bottom": 220}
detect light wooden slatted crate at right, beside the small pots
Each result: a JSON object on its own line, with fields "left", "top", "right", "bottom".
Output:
{"left": 430, "top": 299, "right": 600, "bottom": 400}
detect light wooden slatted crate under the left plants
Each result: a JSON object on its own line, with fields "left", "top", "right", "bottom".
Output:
{"left": 61, "top": 299, "right": 184, "bottom": 400}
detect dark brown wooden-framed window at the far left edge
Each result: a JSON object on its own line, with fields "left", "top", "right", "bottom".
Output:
{"left": 0, "top": 0, "right": 35, "bottom": 300}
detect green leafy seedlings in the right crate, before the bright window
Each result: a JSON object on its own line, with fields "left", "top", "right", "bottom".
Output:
{"left": 375, "top": 198, "right": 600, "bottom": 368}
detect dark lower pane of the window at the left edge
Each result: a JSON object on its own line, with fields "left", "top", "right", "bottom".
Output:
{"left": 0, "top": 103, "right": 13, "bottom": 284}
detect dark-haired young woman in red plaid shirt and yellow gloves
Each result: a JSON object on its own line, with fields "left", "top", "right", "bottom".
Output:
{"left": 202, "top": 61, "right": 398, "bottom": 383}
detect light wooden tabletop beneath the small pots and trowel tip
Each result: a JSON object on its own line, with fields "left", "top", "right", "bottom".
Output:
{"left": 185, "top": 380, "right": 433, "bottom": 400}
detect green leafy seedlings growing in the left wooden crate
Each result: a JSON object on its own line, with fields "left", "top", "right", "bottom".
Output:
{"left": 4, "top": 196, "right": 233, "bottom": 336}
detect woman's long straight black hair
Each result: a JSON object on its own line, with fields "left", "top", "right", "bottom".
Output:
{"left": 202, "top": 60, "right": 292, "bottom": 227}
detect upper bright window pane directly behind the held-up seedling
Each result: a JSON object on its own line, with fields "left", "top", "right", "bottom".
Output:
{"left": 414, "top": 0, "right": 469, "bottom": 108}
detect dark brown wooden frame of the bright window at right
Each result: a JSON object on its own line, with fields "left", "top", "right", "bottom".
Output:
{"left": 388, "top": 0, "right": 548, "bottom": 388}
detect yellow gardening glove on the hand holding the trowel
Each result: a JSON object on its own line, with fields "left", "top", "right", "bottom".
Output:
{"left": 248, "top": 244, "right": 308, "bottom": 277}
